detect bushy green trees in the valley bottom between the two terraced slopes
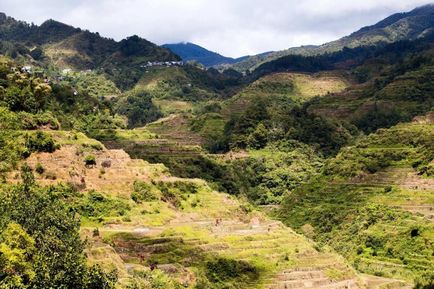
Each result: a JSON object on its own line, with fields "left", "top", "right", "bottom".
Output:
{"left": 129, "top": 141, "right": 323, "bottom": 205}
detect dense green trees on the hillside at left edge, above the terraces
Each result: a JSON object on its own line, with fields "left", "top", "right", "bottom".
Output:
{"left": 0, "top": 58, "right": 125, "bottom": 132}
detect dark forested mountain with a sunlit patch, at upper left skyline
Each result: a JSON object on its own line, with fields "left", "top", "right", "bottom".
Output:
{"left": 0, "top": 13, "right": 180, "bottom": 88}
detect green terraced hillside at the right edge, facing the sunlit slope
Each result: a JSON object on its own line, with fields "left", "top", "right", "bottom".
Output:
{"left": 280, "top": 114, "right": 434, "bottom": 283}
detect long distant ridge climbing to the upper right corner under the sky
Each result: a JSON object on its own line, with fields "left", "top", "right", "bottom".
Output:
{"left": 233, "top": 4, "right": 434, "bottom": 71}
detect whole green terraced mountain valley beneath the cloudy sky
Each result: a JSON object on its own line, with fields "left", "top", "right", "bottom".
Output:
{"left": 0, "top": 5, "right": 434, "bottom": 289}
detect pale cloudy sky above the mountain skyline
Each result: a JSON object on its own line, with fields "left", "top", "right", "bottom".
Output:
{"left": 0, "top": 0, "right": 434, "bottom": 57}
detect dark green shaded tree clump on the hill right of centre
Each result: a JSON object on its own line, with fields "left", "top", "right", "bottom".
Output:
{"left": 225, "top": 98, "right": 355, "bottom": 154}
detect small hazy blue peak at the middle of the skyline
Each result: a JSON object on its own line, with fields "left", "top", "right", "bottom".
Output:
{"left": 163, "top": 42, "right": 247, "bottom": 67}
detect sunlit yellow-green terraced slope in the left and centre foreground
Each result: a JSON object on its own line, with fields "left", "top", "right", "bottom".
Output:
{"left": 11, "top": 132, "right": 376, "bottom": 289}
